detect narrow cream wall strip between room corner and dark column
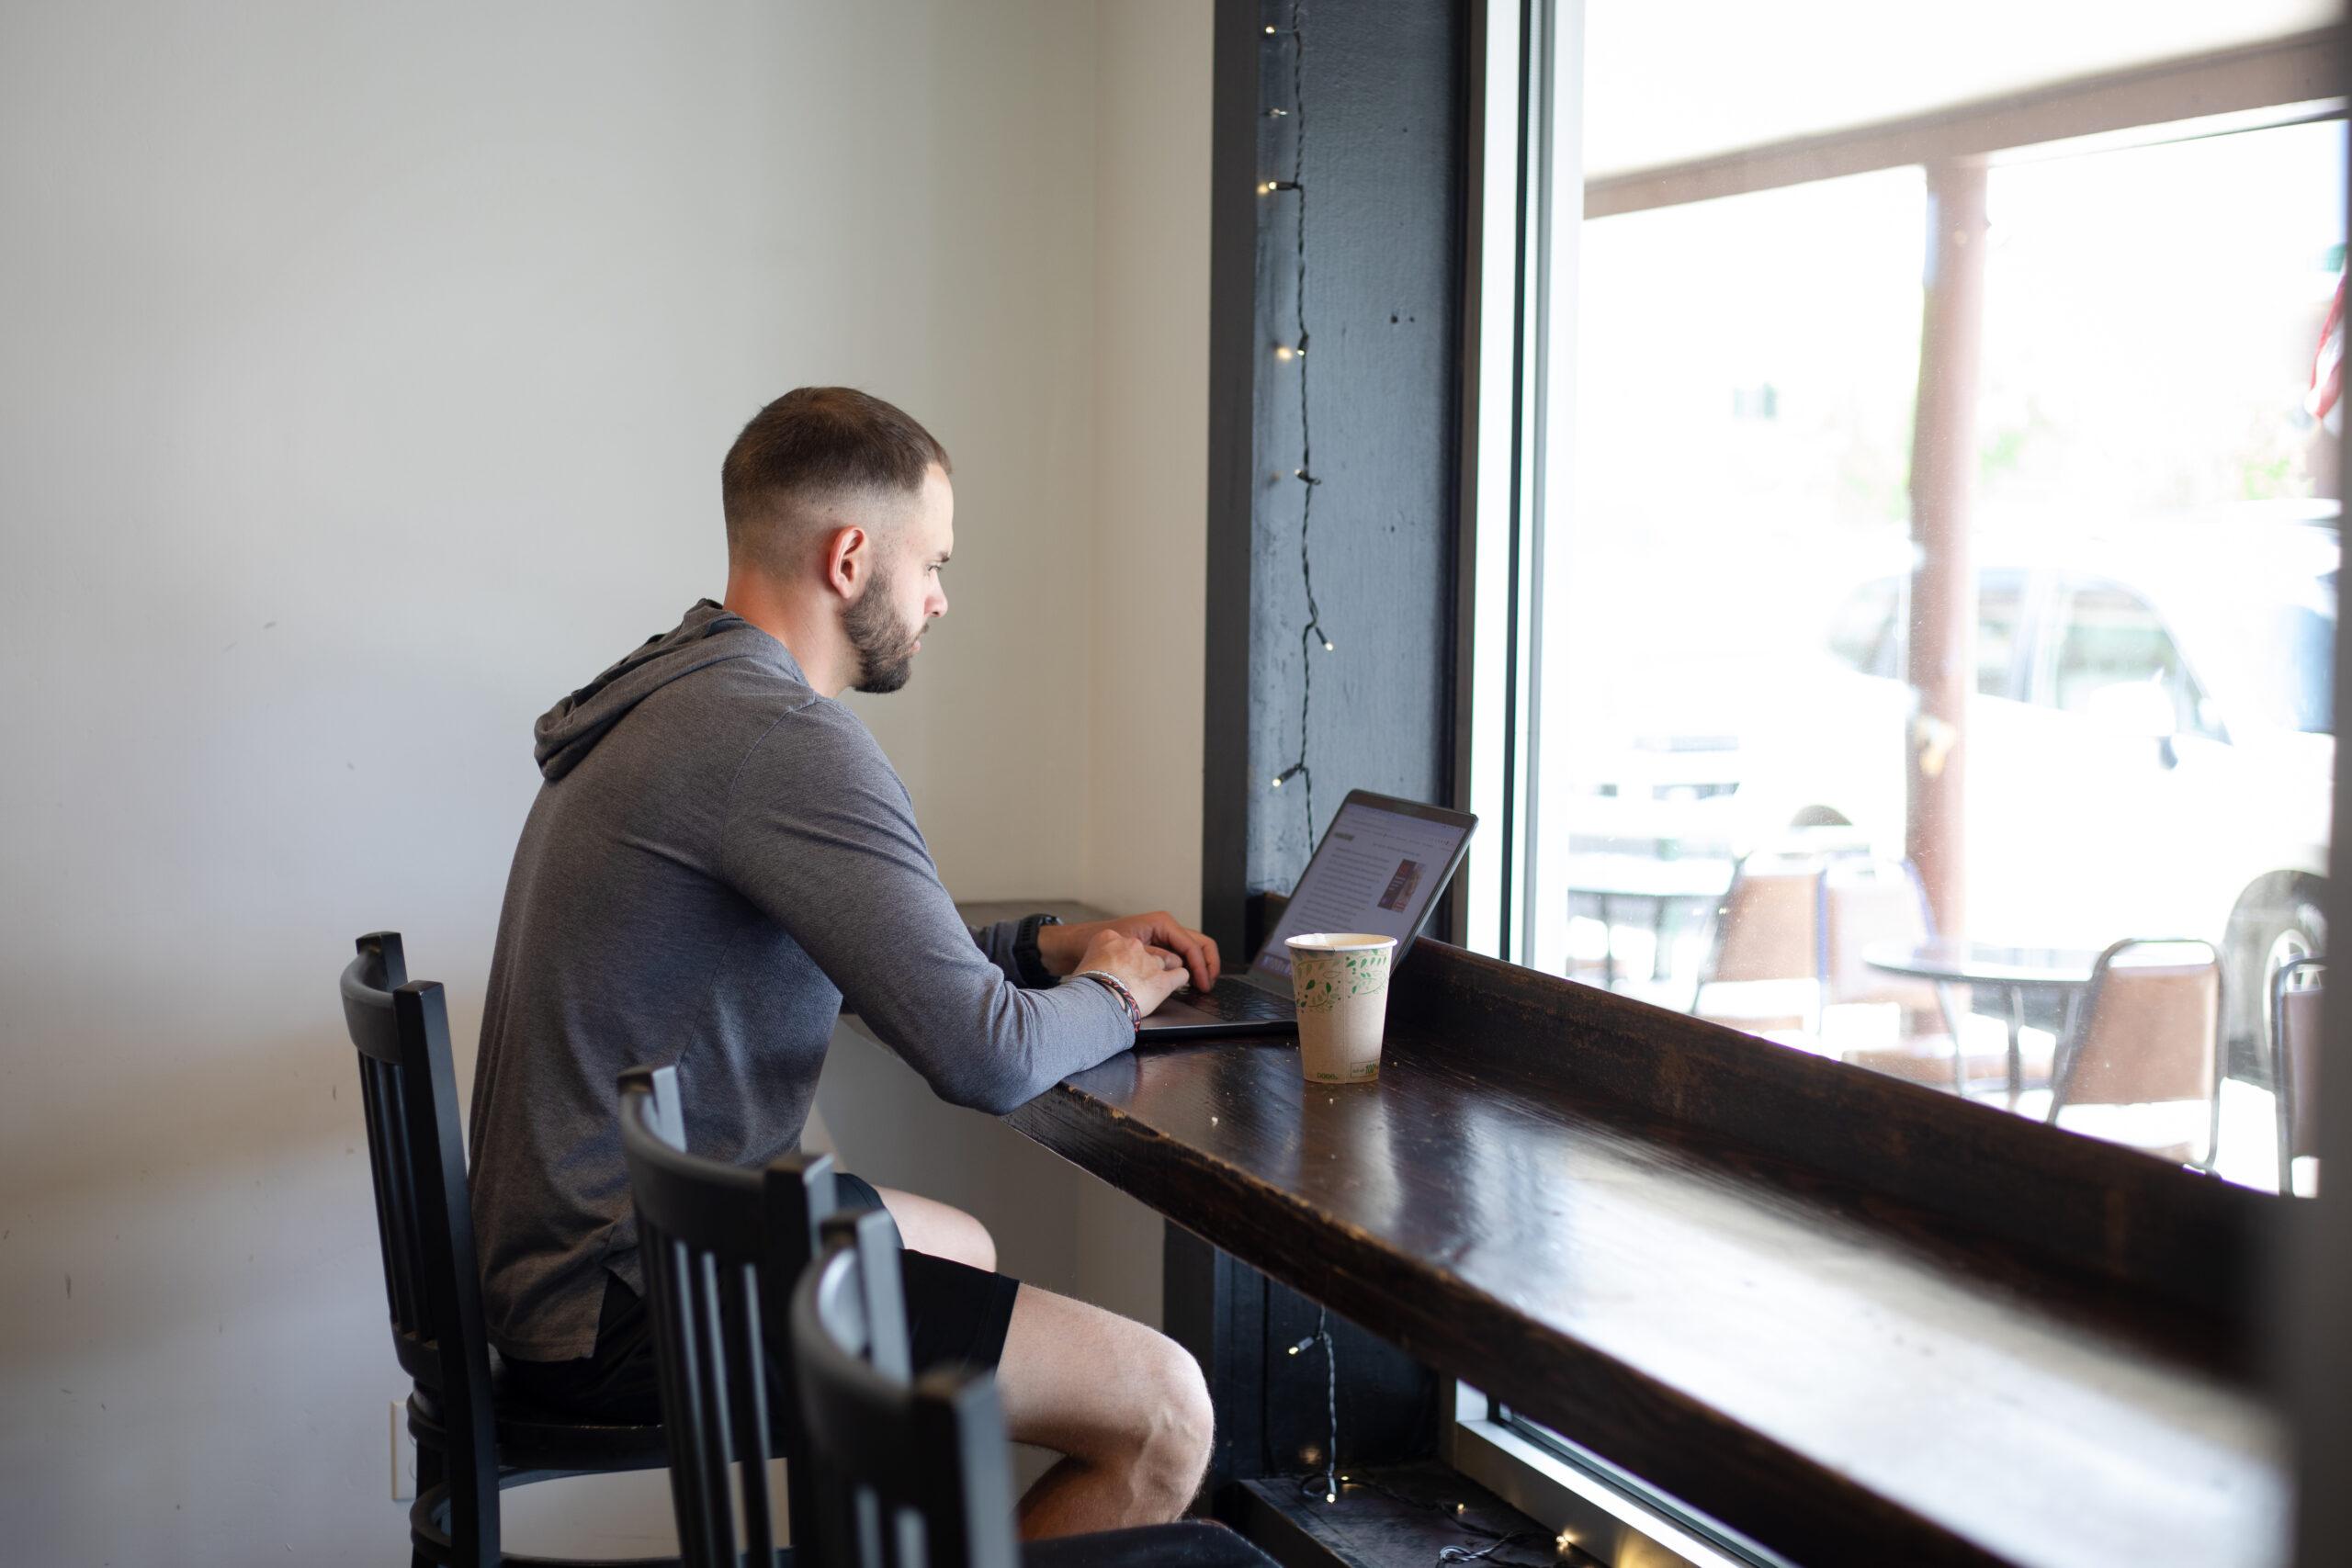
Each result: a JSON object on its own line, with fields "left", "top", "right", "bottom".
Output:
{"left": 1075, "top": 0, "right": 1213, "bottom": 1324}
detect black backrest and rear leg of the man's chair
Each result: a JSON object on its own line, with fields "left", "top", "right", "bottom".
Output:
{"left": 344, "top": 931, "right": 499, "bottom": 1561}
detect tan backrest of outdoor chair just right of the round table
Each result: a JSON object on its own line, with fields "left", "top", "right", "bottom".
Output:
{"left": 2051, "top": 938, "right": 2221, "bottom": 1119}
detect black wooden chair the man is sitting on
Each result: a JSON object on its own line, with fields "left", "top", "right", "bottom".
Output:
{"left": 344, "top": 931, "right": 675, "bottom": 1568}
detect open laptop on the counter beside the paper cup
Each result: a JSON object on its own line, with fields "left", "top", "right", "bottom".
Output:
{"left": 1136, "top": 790, "right": 1477, "bottom": 1043}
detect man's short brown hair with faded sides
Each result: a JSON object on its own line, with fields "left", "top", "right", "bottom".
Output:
{"left": 719, "top": 386, "right": 953, "bottom": 564}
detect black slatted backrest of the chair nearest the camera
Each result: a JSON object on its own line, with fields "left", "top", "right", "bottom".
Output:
{"left": 793, "top": 1213, "right": 1021, "bottom": 1568}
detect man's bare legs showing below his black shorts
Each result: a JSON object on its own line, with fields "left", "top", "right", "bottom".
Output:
{"left": 877, "top": 1187, "right": 1214, "bottom": 1540}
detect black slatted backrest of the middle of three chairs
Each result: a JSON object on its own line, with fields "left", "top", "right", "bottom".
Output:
{"left": 621, "top": 1067, "right": 855, "bottom": 1568}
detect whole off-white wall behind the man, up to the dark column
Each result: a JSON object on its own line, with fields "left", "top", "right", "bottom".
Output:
{"left": 0, "top": 0, "right": 1209, "bottom": 1563}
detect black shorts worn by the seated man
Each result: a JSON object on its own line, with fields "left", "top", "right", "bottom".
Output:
{"left": 505, "top": 1170, "right": 1021, "bottom": 1425}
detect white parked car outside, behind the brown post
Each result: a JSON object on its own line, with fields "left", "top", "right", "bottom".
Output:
{"left": 1569, "top": 501, "right": 2340, "bottom": 1042}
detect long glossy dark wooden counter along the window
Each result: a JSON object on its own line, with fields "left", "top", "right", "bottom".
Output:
{"left": 968, "top": 907, "right": 2286, "bottom": 1568}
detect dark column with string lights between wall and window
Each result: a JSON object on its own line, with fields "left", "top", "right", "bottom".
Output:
{"left": 1185, "top": 0, "right": 1470, "bottom": 1493}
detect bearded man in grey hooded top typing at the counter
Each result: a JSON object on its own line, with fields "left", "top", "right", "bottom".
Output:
{"left": 473, "top": 388, "right": 1218, "bottom": 1538}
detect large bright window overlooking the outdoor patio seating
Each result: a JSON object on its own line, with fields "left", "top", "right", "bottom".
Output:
{"left": 1473, "top": 0, "right": 2345, "bottom": 1187}
